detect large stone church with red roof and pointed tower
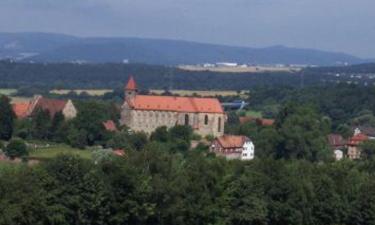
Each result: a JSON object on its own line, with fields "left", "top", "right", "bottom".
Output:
{"left": 120, "top": 77, "right": 226, "bottom": 137}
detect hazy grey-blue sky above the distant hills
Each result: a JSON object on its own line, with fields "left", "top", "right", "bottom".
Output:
{"left": 0, "top": 0, "right": 375, "bottom": 58}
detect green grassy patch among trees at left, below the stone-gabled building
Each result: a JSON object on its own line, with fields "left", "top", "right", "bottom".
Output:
{"left": 30, "top": 145, "right": 91, "bottom": 160}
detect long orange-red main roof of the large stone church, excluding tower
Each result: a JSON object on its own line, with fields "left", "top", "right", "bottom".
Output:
{"left": 128, "top": 95, "right": 224, "bottom": 113}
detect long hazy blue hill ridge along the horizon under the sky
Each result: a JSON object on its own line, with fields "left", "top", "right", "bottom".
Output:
{"left": 0, "top": 33, "right": 368, "bottom": 65}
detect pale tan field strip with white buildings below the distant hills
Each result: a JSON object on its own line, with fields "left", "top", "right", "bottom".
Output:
{"left": 178, "top": 65, "right": 301, "bottom": 73}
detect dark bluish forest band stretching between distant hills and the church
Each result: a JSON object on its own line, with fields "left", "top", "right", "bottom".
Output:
{"left": 0, "top": 61, "right": 374, "bottom": 90}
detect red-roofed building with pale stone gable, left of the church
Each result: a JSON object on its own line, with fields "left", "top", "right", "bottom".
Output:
{"left": 12, "top": 95, "right": 77, "bottom": 119}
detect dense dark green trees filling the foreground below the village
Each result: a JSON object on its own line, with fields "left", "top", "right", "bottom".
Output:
{"left": 0, "top": 150, "right": 375, "bottom": 225}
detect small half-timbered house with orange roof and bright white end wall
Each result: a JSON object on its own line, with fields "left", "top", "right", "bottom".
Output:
{"left": 210, "top": 135, "right": 255, "bottom": 160}
